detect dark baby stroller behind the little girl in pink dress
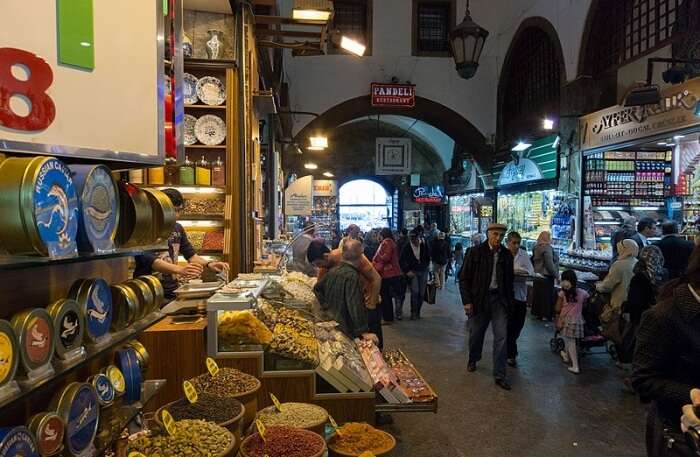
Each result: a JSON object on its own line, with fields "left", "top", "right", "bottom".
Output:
{"left": 549, "top": 284, "right": 617, "bottom": 360}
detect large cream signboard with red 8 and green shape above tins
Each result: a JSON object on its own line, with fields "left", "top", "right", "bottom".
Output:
{"left": 0, "top": 0, "right": 164, "bottom": 163}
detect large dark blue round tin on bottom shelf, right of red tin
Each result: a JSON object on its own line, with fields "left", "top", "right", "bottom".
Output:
{"left": 51, "top": 382, "right": 100, "bottom": 456}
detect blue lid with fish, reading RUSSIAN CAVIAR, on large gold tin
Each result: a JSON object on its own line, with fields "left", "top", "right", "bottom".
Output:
{"left": 33, "top": 158, "right": 79, "bottom": 258}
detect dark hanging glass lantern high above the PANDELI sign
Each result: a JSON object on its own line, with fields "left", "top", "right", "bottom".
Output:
{"left": 450, "top": 1, "right": 489, "bottom": 79}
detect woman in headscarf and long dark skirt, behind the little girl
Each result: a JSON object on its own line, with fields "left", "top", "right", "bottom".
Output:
{"left": 532, "top": 231, "right": 559, "bottom": 321}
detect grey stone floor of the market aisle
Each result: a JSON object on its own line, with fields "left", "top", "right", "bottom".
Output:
{"left": 384, "top": 284, "right": 645, "bottom": 457}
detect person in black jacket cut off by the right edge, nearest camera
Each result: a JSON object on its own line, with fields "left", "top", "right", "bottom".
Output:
{"left": 632, "top": 246, "right": 700, "bottom": 457}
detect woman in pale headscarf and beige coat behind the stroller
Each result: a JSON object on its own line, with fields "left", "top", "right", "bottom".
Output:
{"left": 596, "top": 239, "right": 639, "bottom": 348}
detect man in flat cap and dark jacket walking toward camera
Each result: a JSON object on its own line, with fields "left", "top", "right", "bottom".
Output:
{"left": 459, "top": 224, "right": 513, "bottom": 390}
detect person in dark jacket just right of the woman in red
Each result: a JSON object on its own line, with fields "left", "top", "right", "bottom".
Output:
{"left": 399, "top": 229, "right": 430, "bottom": 320}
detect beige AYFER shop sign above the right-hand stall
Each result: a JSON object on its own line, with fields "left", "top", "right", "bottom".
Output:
{"left": 579, "top": 78, "right": 700, "bottom": 150}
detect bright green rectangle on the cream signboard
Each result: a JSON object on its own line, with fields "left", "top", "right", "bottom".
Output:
{"left": 56, "top": 0, "right": 95, "bottom": 70}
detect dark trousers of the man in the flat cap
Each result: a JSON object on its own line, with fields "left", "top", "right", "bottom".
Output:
{"left": 469, "top": 293, "right": 508, "bottom": 379}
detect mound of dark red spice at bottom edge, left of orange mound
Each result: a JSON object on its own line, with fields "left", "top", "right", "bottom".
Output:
{"left": 243, "top": 427, "right": 325, "bottom": 457}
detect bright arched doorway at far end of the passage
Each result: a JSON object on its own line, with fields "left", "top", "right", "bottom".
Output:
{"left": 338, "top": 179, "right": 391, "bottom": 232}
